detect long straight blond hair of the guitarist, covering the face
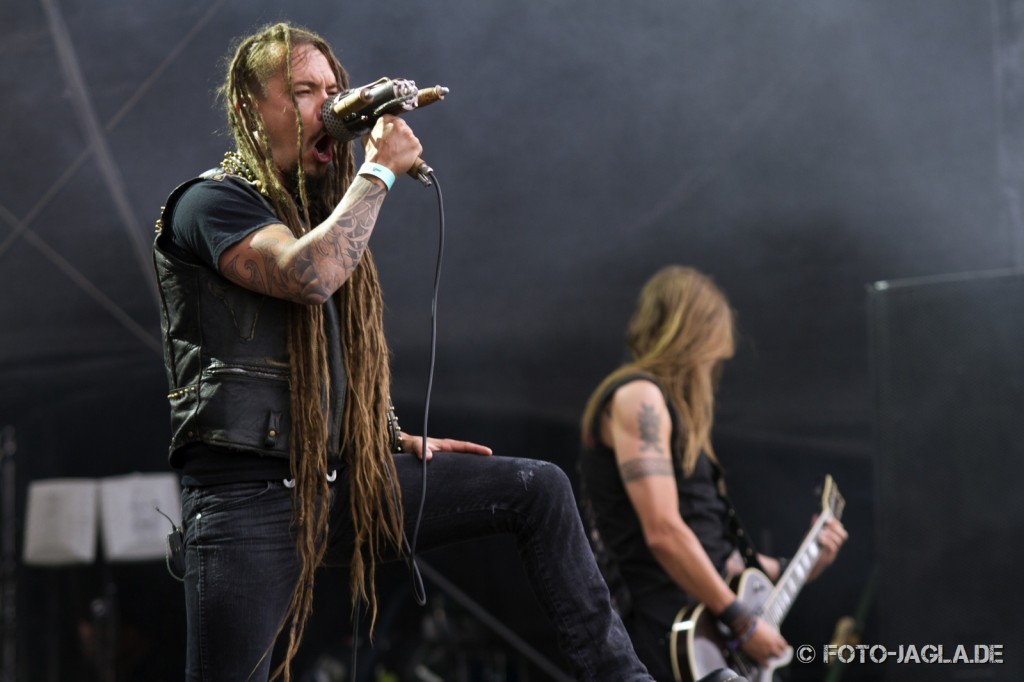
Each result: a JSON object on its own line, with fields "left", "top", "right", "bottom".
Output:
{"left": 581, "top": 265, "right": 734, "bottom": 476}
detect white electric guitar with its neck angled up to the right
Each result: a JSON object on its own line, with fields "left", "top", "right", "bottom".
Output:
{"left": 669, "top": 475, "right": 846, "bottom": 682}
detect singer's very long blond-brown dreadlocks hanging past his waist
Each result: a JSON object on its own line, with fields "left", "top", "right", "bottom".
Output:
{"left": 220, "top": 24, "right": 402, "bottom": 682}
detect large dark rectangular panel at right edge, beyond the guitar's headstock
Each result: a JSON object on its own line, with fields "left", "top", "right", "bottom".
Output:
{"left": 865, "top": 270, "right": 1024, "bottom": 682}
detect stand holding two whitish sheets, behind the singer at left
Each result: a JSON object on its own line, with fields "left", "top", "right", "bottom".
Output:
{"left": 23, "top": 473, "right": 181, "bottom": 682}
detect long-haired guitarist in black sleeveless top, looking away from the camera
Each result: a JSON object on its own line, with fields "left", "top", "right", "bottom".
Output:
{"left": 579, "top": 265, "right": 847, "bottom": 681}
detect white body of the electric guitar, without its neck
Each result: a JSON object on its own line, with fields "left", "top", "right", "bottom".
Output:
{"left": 669, "top": 568, "right": 793, "bottom": 682}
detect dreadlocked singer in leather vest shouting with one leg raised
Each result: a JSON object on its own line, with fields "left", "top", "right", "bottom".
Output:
{"left": 154, "top": 24, "right": 650, "bottom": 682}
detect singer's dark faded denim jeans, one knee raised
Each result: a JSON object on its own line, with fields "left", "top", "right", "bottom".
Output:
{"left": 182, "top": 453, "right": 651, "bottom": 682}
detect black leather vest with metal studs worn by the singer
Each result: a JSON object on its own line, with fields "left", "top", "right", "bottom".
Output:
{"left": 154, "top": 171, "right": 345, "bottom": 466}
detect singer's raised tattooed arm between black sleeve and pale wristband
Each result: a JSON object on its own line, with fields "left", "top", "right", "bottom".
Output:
{"left": 221, "top": 178, "right": 387, "bottom": 304}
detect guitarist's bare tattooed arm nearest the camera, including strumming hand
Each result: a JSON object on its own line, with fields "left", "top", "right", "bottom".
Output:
{"left": 601, "top": 380, "right": 785, "bottom": 662}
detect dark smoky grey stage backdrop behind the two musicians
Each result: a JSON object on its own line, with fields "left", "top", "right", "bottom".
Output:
{"left": 0, "top": 0, "right": 1024, "bottom": 680}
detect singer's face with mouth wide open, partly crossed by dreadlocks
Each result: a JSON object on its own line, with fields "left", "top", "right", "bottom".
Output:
{"left": 256, "top": 45, "right": 339, "bottom": 177}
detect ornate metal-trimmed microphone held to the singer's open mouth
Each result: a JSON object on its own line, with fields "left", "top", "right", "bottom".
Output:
{"left": 322, "top": 78, "right": 449, "bottom": 186}
